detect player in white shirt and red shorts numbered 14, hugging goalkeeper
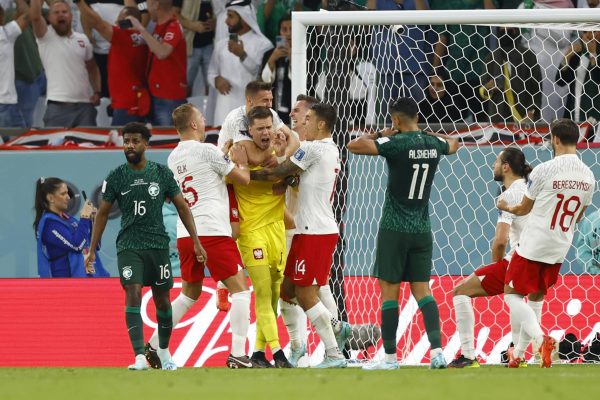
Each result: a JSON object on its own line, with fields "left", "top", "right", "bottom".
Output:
{"left": 251, "top": 103, "right": 346, "bottom": 368}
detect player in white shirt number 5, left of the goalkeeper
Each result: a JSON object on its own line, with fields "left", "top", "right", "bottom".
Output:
{"left": 147, "top": 104, "right": 252, "bottom": 368}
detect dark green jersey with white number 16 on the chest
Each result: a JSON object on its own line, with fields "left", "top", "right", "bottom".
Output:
{"left": 102, "top": 161, "right": 180, "bottom": 253}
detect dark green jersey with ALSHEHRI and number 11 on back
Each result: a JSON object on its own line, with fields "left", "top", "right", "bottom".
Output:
{"left": 375, "top": 131, "right": 449, "bottom": 233}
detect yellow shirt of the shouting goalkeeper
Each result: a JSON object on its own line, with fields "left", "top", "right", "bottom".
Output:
{"left": 233, "top": 167, "right": 285, "bottom": 233}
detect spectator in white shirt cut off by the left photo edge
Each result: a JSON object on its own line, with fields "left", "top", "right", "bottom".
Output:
{"left": 0, "top": 0, "right": 29, "bottom": 128}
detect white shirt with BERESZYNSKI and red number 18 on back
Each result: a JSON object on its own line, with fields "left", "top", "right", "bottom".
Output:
{"left": 517, "top": 154, "right": 596, "bottom": 264}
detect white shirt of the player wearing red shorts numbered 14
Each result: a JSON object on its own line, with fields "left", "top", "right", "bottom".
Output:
{"left": 290, "top": 138, "right": 340, "bottom": 235}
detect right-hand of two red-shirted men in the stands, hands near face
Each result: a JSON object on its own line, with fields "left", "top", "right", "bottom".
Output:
{"left": 130, "top": 0, "right": 187, "bottom": 126}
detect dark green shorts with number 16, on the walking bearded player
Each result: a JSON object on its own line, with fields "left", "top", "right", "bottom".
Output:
{"left": 117, "top": 249, "right": 173, "bottom": 289}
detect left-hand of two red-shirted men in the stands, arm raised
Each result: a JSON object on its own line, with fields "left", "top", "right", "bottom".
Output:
{"left": 77, "top": 1, "right": 150, "bottom": 126}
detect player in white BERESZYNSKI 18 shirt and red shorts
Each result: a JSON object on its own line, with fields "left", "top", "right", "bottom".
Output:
{"left": 498, "top": 119, "right": 596, "bottom": 368}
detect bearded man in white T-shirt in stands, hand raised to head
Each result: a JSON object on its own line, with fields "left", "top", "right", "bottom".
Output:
{"left": 30, "top": 0, "right": 100, "bottom": 128}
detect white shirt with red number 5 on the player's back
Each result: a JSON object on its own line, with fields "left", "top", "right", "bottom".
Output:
{"left": 167, "top": 140, "right": 234, "bottom": 238}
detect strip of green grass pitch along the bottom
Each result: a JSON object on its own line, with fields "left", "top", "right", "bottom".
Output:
{"left": 0, "top": 365, "right": 600, "bottom": 400}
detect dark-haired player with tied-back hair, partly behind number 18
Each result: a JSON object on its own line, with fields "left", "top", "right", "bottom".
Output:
{"left": 448, "top": 147, "right": 532, "bottom": 368}
